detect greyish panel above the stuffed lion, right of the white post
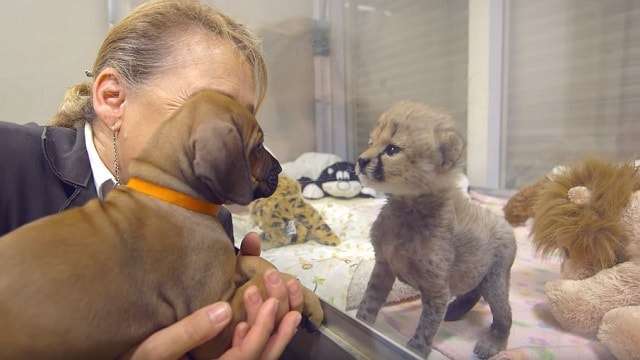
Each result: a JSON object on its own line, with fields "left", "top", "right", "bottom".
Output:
{"left": 504, "top": 0, "right": 640, "bottom": 188}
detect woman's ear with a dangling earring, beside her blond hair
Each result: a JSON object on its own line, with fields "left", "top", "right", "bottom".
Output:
{"left": 92, "top": 68, "right": 127, "bottom": 131}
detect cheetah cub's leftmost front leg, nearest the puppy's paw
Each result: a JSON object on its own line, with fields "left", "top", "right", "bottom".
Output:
{"left": 356, "top": 260, "right": 396, "bottom": 324}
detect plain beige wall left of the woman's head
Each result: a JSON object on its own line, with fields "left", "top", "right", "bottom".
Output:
{"left": 0, "top": 0, "right": 107, "bottom": 123}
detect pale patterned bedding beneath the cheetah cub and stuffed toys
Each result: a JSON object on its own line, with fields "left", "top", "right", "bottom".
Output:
{"left": 233, "top": 191, "right": 613, "bottom": 360}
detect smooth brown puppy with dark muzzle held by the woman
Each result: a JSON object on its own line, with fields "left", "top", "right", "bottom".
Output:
{"left": 0, "top": 91, "right": 323, "bottom": 359}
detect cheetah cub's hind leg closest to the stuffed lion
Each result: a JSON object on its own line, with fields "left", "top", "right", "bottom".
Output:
{"left": 473, "top": 264, "right": 511, "bottom": 359}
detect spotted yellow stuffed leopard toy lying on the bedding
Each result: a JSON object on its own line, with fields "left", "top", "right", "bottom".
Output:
{"left": 249, "top": 175, "right": 340, "bottom": 248}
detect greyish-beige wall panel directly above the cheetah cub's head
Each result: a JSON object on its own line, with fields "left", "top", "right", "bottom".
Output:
{"left": 347, "top": 0, "right": 468, "bottom": 153}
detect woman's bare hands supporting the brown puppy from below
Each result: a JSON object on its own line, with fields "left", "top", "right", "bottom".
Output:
{"left": 126, "top": 233, "right": 303, "bottom": 360}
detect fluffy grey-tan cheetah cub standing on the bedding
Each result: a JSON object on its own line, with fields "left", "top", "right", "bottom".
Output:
{"left": 357, "top": 102, "right": 516, "bottom": 358}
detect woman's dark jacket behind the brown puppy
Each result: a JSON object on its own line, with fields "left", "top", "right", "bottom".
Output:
{"left": 0, "top": 122, "right": 233, "bottom": 240}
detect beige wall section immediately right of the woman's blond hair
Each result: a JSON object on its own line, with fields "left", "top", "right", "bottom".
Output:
{"left": 207, "top": 0, "right": 315, "bottom": 161}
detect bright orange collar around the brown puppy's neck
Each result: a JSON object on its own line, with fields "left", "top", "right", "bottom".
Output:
{"left": 127, "top": 178, "right": 220, "bottom": 216}
